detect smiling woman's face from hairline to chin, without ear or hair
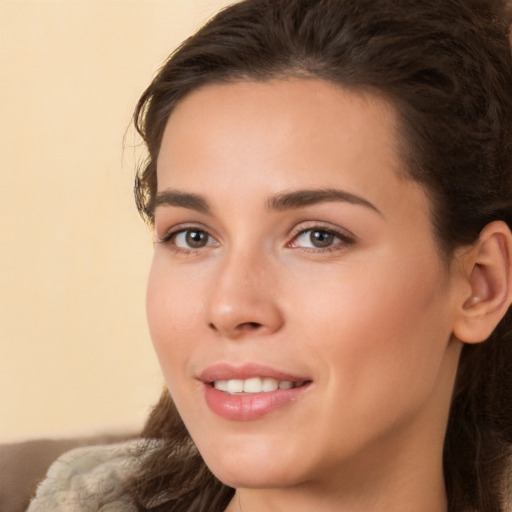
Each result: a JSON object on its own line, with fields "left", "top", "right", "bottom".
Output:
{"left": 147, "top": 79, "right": 461, "bottom": 487}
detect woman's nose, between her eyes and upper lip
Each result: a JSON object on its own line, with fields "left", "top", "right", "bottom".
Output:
{"left": 207, "top": 252, "right": 284, "bottom": 339}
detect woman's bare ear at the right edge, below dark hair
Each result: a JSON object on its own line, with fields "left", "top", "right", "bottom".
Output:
{"left": 453, "top": 221, "right": 512, "bottom": 343}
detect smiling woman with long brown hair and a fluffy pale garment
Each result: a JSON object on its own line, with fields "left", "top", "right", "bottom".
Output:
{"left": 30, "top": 0, "right": 512, "bottom": 512}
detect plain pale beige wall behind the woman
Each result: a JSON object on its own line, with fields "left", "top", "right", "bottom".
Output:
{"left": 0, "top": 0, "right": 233, "bottom": 441}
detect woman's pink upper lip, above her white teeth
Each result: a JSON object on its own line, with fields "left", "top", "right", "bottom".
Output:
{"left": 198, "top": 363, "right": 311, "bottom": 383}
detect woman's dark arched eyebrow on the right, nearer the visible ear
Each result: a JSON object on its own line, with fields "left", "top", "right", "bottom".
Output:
{"left": 267, "top": 188, "right": 383, "bottom": 216}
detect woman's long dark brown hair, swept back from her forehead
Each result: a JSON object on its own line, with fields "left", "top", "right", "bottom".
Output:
{"left": 129, "top": 0, "right": 512, "bottom": 512}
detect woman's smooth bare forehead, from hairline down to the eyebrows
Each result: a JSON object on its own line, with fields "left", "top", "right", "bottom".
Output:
{"left": 157, "top": 79, "right": 425, "bottom": 223}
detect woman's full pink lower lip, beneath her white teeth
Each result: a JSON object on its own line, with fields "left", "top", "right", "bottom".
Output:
{"left": 205, "top": 384, "right": 309, "bottom": 421}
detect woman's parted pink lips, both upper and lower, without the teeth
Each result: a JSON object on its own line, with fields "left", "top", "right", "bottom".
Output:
{"left": 199, "top": 364, "right": 311, "bottom": 421}
